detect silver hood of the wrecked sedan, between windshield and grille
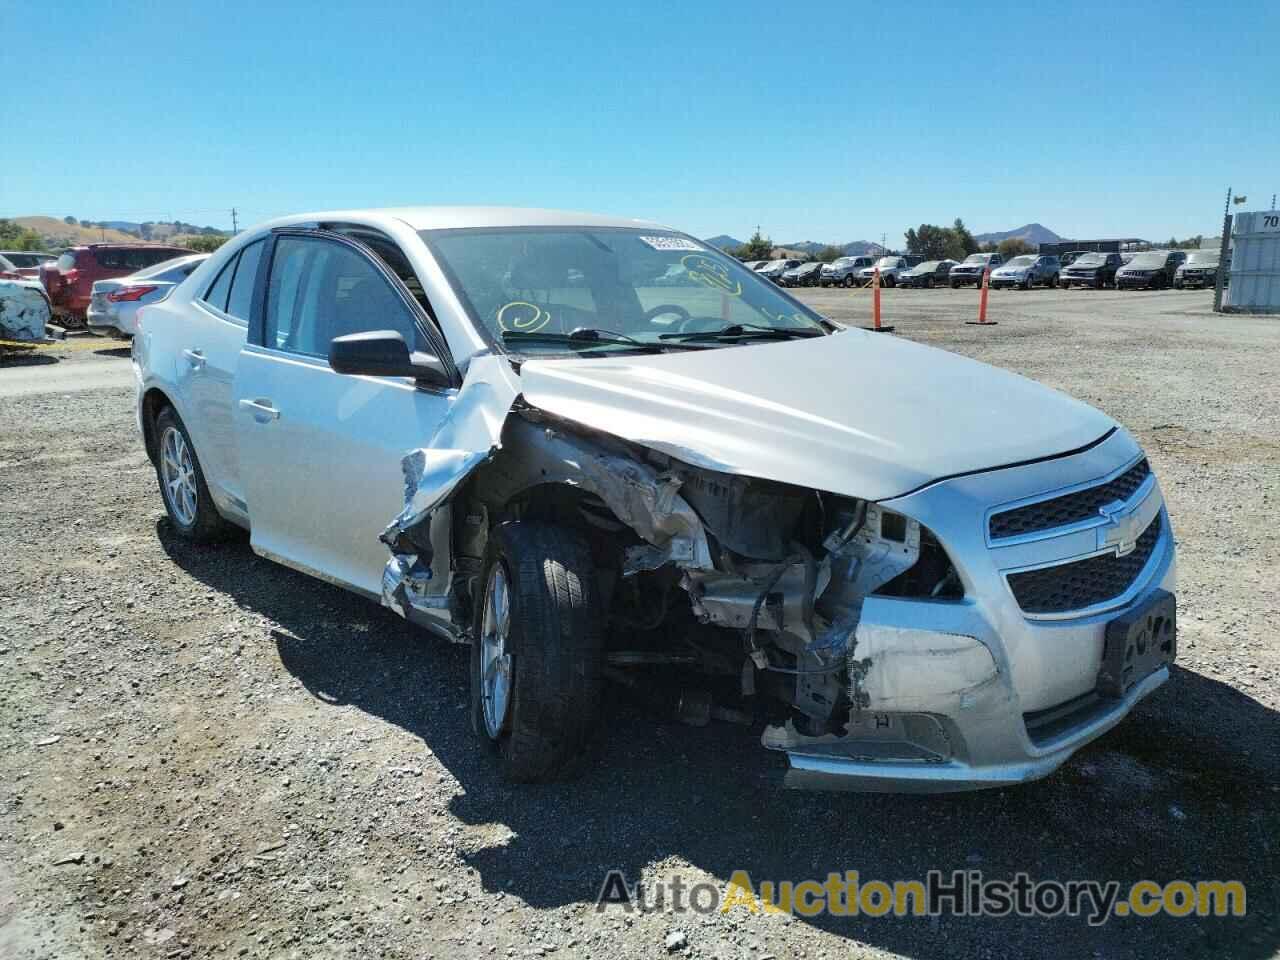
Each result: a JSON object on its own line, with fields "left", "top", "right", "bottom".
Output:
{"left": 520, "top": 330, "right": 1115, "bottom": 500}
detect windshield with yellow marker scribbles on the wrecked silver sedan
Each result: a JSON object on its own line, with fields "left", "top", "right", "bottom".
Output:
{"left": 421, "top": 227, "right": 827, "bottom": 353}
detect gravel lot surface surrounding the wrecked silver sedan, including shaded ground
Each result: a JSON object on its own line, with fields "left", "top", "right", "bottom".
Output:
{"left": 0, "top": 289, "right": 1280, "bottom": 960}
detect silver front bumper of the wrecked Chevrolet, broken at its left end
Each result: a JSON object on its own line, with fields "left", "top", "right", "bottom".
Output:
{"left": 767, "top": 430, "right": 1176, "bottom": 792}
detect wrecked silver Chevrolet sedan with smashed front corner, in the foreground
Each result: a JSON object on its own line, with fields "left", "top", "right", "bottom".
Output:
{"left": 133, "top": 207, "right": 1175, "bottom": 791}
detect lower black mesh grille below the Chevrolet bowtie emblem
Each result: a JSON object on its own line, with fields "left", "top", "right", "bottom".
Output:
{"left": 1009, "top": 513, "right": 1165, "bottom": 613}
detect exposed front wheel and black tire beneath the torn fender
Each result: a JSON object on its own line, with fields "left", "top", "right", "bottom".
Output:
{"left": 471, "top": 522, "right": 604, "bottom": 783}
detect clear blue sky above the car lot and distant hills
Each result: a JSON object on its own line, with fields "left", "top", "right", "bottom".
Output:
{"left": 0, "top": 0, "right": 1280, "bottom": 243}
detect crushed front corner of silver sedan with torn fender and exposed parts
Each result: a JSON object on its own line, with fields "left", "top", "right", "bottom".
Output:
{"left": 383, "top": 360, "right": 988, "bottom": 788}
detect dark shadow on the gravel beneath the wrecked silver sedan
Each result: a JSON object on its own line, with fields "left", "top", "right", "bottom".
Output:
{"left": 157, "top": 520, "right": 1280, "bottom": 957}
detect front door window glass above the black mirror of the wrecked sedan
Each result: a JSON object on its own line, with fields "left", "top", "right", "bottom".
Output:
{"left": 264, "top": 237, "right": 422, "bottom": 357}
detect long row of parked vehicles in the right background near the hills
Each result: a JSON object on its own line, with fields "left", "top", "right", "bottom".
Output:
{"left": 746, "top": 250, "right": 1219, "bottom": 291}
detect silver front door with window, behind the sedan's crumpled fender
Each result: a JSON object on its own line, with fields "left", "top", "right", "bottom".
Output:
{"left": 234, "top": 230, "right": 456, "bottom": 596}
